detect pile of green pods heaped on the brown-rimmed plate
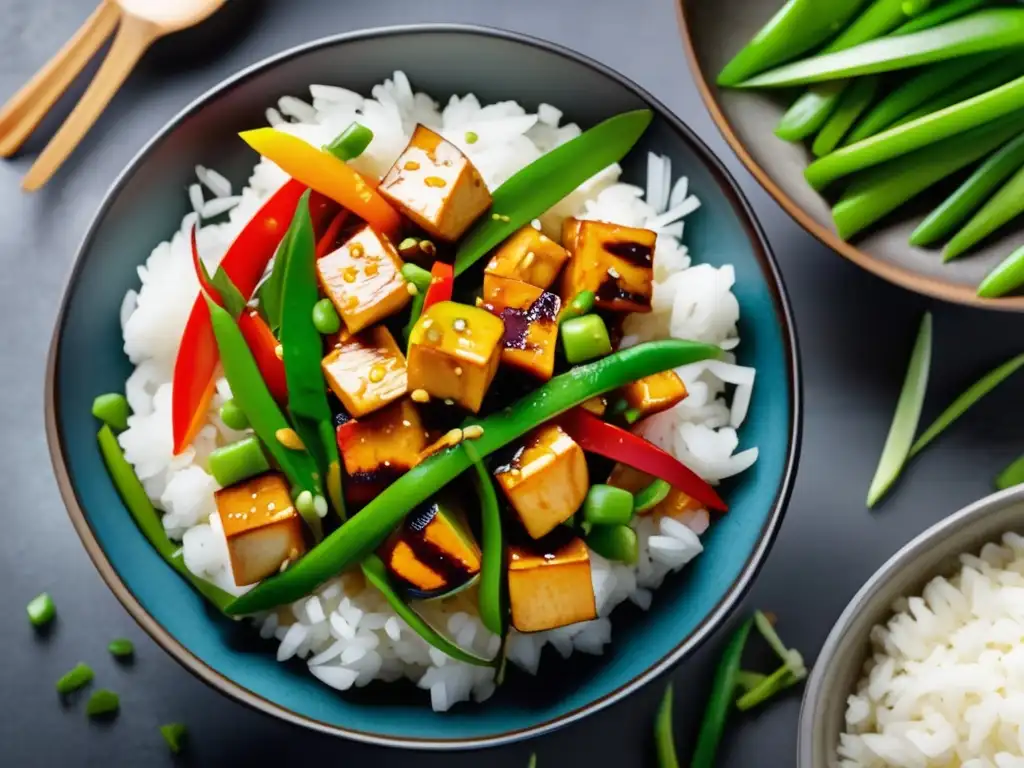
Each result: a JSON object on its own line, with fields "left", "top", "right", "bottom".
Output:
{"left": 719, "top": 0, "right": 1024, "bottom": 298}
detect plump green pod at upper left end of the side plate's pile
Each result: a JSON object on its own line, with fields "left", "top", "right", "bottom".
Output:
{"left": 718, "top": 0, "right": 864, "bottom": 86}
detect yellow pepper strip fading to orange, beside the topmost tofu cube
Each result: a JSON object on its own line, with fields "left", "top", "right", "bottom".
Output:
{"left": 239, "top": 128, "right": 401, "bottom": 237}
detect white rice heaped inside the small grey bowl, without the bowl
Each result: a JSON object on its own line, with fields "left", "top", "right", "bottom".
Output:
{"left": 839, "top": 532, "right": 1024, "bottom": 768}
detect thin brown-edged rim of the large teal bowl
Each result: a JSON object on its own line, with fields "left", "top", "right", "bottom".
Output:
{"left": 44, "top": 24, "right": 803, "bottom": 750}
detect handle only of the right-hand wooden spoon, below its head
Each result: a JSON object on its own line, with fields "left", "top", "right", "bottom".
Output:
{"left": 22, "top": 15, "right": 161, "bottom": 191}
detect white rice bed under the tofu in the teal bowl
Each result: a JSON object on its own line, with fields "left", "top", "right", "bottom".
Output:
{"left": 120, "top": 72, "right": 757, "bottom": 711}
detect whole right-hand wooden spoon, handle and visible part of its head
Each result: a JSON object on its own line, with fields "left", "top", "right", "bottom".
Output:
{"left": 22, "top": 0, "right": 224, "bottom": 191}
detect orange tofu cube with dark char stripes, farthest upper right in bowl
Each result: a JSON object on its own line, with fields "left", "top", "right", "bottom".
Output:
{"left": 561, "top": 219, "right": 657, "bottom": 312}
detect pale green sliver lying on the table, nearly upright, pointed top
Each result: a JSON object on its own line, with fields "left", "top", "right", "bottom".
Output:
{"left": 867, "top": 312, "right": 932, "bottom": 508}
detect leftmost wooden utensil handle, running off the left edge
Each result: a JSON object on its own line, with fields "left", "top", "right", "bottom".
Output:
{"left": 0, "top": 0, "right": 121, "bottom": 158}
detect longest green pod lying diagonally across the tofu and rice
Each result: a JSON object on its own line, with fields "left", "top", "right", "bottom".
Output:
{"left": 229, "top": 339, "right": 721, "bottom": 615}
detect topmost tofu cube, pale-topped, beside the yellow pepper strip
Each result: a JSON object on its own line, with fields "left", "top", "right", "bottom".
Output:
{"left": 378, "top": 125, "right": 490, "bottom": 242}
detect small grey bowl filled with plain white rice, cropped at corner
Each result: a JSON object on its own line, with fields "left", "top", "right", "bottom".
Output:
{"left": 798, "top": 486, "right": 1024, "bottom": 768}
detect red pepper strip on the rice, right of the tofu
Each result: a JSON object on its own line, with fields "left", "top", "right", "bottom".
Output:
{"left": 558, "top": 408, "right": 729, "bottom": 512}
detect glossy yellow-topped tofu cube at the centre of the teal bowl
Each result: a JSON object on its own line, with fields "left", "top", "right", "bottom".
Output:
{"left": 409, "top": 301, "right": 505, "bottom": 414}
